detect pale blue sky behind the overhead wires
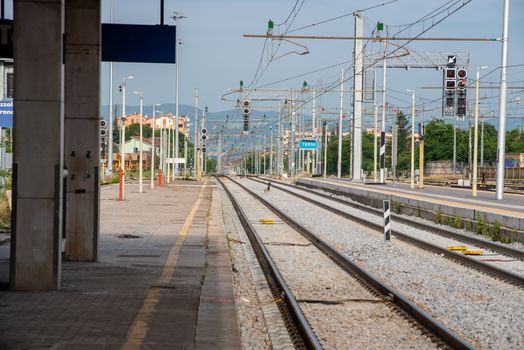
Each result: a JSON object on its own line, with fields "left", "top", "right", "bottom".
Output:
{"left": 101, "top": 0, "right": 524, "bottom": 130}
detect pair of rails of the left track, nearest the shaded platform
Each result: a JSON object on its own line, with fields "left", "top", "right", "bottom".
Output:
{"left": 219, "top": 179, "right": 474, "bottom": 349}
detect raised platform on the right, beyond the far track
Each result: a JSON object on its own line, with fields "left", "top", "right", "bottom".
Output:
{"left": 296, "top": 178, "right": 524, "bottom": 235}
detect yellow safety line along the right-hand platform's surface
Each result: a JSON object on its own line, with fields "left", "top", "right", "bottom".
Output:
{"left": 314, "top": 179, "right": 524, "bottom": 218}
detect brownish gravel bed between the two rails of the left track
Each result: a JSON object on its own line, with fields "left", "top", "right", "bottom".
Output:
{"left": 224, "top": 182, "right": 437, "bottom": 349}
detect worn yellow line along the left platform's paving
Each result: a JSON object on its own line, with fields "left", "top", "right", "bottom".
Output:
{"left": 121, "top": 180, "right": 207, "bottom": 350}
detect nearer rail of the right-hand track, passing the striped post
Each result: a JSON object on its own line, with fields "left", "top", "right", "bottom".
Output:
{"left": 249, "top": 176, "right": 524, "bottom": 287}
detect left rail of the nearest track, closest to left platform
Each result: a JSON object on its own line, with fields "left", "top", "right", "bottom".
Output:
{"left": 216, "top": 177, "right": 322, "bottom": 349}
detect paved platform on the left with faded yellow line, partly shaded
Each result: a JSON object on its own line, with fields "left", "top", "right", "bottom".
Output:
{"left": 0, "top": 181, "right": 241, "bottom": 349}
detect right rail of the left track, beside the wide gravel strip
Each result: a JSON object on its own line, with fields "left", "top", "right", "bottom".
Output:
{"left": 229, "top": 178, "right": 475, "bottom": 349}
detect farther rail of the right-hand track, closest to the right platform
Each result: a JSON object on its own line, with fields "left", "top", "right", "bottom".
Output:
{"left": 254, "top": 177, "right": 524, "bottom": 261}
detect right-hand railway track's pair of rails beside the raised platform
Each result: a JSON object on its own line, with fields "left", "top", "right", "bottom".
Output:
{"left": 250, "top": 177, "right": 524, "bottom": 288}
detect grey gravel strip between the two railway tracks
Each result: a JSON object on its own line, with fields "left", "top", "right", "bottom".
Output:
{"left": 241, "top": 180, "right": 524, "bottom": 349}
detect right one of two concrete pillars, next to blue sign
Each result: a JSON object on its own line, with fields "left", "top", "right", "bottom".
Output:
{"left": 65, "top": 0, "right": 101, "bottom": 261}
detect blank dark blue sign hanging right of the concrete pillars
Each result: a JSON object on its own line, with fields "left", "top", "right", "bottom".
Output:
{"left": 102, "top": 23, "right": 176, "bottom": 63}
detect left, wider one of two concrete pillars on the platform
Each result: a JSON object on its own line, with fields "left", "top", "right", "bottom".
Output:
{"left": 10, "top": 0, "right": 64, "bottom": 290}
